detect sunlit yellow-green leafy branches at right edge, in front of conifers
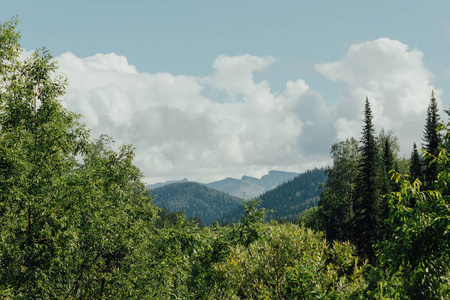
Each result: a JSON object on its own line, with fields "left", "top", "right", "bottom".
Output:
{"left": 379, "top": 121, "right": 450, "bottom": 299}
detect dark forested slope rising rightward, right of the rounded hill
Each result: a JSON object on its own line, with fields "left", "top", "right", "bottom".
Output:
{"left": 219, "top": 168, "right": 326, "bottom": 223}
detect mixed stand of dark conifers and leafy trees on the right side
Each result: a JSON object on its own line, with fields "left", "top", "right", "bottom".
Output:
{"left": 301, "top": 92, "right": 450, "bottom": 299}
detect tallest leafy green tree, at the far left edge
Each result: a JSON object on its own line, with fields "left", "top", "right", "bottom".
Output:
{"left": 0, "top": 20, "right": 86, "bottom": 298}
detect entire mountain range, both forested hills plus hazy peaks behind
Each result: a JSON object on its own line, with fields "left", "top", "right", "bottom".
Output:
{"left": 150, "top": 169, "right": 326, "bottom": 225}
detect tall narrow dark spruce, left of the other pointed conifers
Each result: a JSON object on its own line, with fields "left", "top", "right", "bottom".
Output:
{"left": 351, "top": 97, "right": 380, "bottom": 261}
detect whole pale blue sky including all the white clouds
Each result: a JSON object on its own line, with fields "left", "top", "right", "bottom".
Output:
{"left": 0, "top": 0, "right": 450, "bottom": 183}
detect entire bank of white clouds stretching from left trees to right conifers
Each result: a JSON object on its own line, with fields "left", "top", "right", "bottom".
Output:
{"left": 56, "top": 39, "right": 441, "bottom": 183}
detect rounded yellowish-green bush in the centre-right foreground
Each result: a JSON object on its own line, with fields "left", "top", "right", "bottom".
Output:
{"left": 214, "top": 224, "right": 366, "bottom": 299}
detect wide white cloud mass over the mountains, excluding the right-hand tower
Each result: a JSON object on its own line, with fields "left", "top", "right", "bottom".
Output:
{"left": 57, "top": 53, "right": 333, "bottom": 182}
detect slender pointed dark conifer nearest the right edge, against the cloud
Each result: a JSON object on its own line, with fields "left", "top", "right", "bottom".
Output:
{"left": 422, "top": 91, "right": 442, "bottom": 189}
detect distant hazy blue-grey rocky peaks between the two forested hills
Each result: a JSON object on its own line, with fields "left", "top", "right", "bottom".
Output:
{"left": 206, "top": 171, "right": 299, "bottom": 199}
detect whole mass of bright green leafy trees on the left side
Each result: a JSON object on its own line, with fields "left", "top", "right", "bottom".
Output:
{"left": 0, "top": 19, "right": 155, "bottom": 299}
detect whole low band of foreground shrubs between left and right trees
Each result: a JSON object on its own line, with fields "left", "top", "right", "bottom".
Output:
{"left": 138, "top": 201, "right": 367, "bottom": 299}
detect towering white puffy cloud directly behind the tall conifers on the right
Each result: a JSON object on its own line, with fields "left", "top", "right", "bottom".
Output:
{"left": 315, "top": 38, "right": 442, "bottom": 153}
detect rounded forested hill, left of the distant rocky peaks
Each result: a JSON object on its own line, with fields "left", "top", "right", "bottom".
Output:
{"left": 151, "top": 181, "right": 242, "bottom": 225}
